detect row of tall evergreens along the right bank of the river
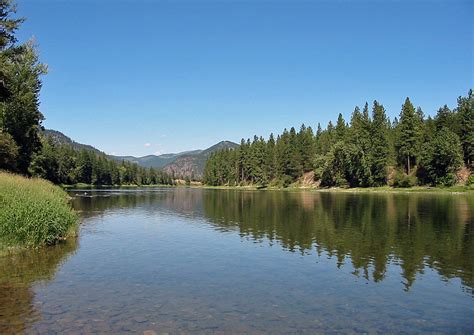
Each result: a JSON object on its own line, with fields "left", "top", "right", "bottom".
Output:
{"left": 204, "top": 89, "right": 474, "bottom": 187}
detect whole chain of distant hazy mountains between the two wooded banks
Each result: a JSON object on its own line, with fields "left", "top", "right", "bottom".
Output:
{"left": 43, "top": 129, "right": 239, "bottom": 179}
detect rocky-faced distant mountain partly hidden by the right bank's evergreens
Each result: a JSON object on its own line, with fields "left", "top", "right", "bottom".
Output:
{"left": 163, "top": 141, "right": 239, "bottom": 179}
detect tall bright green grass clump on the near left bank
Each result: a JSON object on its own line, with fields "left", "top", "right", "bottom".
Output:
{"left": 0, "top": 171, "right": 78, "bottom": 254}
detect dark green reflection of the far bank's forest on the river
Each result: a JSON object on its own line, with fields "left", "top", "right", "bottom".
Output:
{"left": 70, "top": 188, "right": 474, "bottom": 294}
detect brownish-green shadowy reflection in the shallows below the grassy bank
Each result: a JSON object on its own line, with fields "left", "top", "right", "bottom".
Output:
{"left": 0, "top": 239, "right": 77, "bottom": 334}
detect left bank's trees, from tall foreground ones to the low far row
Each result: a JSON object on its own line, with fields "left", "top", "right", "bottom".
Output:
{"left": 0, "top": 0, "right": 173, "bottom": 185}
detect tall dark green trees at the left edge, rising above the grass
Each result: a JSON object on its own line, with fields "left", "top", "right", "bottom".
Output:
{"left": 0, "top": 0, "right": 47, "bottom": 173}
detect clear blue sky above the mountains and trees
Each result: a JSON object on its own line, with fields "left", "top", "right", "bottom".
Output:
{"left": 17, "top": 0, "right": 474, "bottom": 156}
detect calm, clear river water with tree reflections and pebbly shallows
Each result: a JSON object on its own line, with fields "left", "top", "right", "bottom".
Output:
{"left": 0, "top": 189, "right": 474, "bottom": 334}
